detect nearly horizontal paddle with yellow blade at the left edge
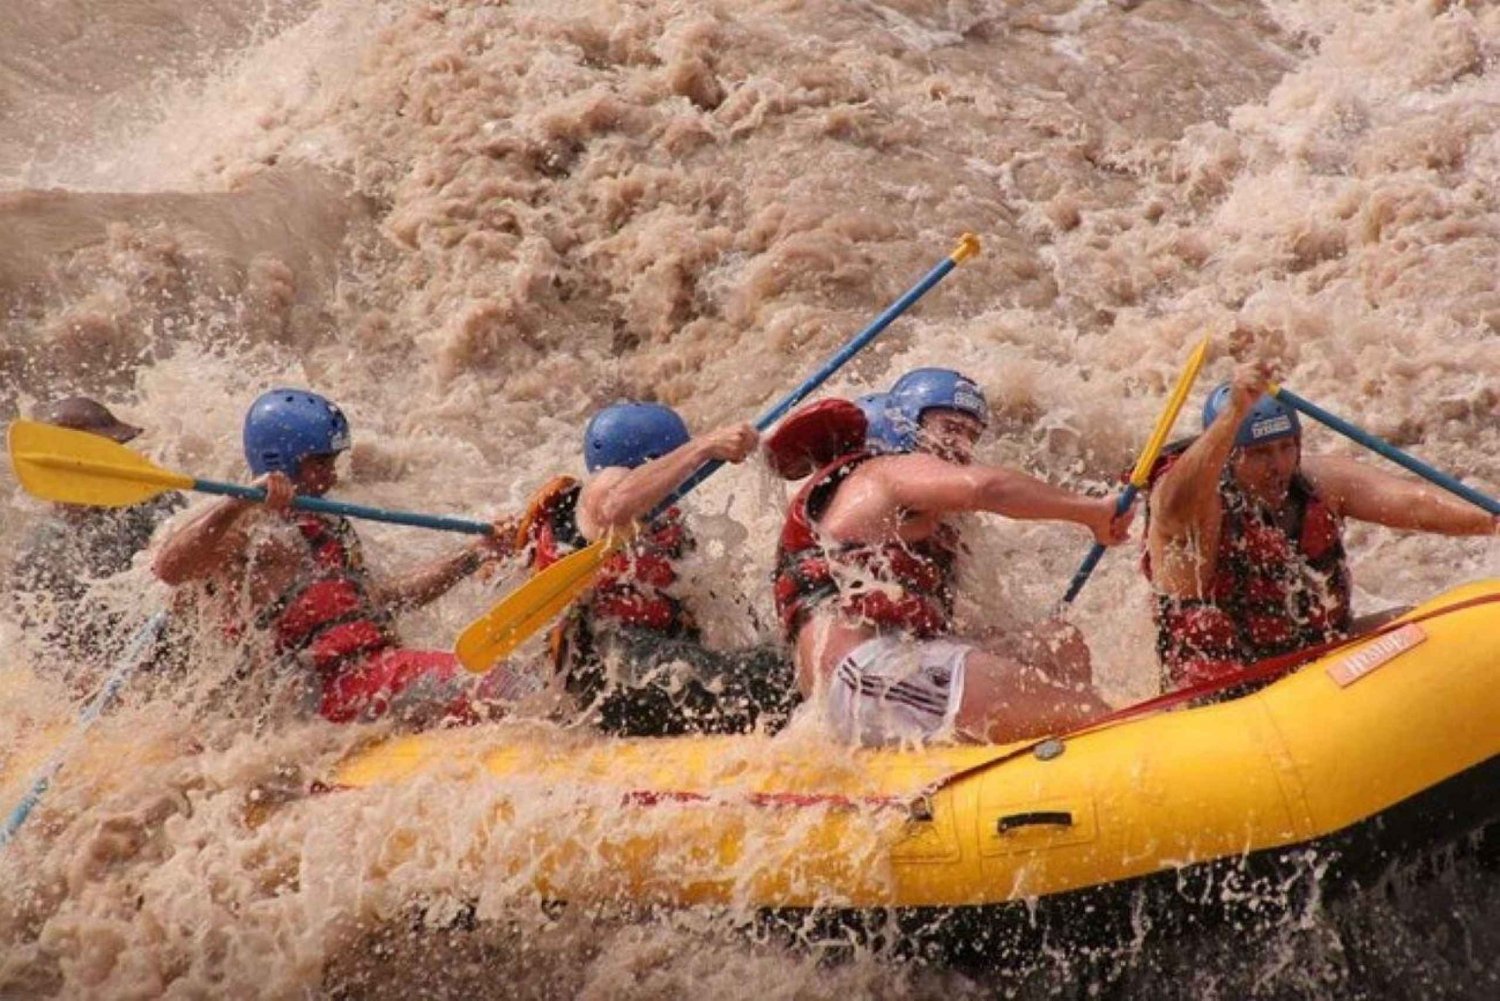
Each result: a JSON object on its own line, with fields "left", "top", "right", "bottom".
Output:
{"left": 6, "top": 420, "right": 491, "bottom": 536}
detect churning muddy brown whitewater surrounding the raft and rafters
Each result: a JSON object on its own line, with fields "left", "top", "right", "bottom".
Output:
{"left": 0, "top": 0, "right": 1500, "bottom": 998}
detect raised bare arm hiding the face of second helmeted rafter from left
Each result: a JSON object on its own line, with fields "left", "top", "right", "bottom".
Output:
{"left": 578, "top": 425, "right": 759, "bottom": 542}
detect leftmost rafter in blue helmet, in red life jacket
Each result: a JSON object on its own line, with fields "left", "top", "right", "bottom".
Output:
{"left": 153, "top": 389, "right": 516, "bottom": 723}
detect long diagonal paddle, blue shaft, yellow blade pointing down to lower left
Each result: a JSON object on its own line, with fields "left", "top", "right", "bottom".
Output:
{"left": 455, "top": 233, "right": 980, "bottom": 674}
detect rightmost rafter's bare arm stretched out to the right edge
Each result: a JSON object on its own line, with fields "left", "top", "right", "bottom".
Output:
{"left": 1302, "top": 455, "right": 1500, "bottom": 536}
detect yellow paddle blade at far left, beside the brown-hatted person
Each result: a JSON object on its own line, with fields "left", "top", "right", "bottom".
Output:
{"left": 6, "top": 420, "right": 194, "bottom": 507}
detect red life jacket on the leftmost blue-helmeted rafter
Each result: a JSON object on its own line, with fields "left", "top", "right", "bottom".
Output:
{"left": 258, "top": 512, "right": 396, "bottom": 680}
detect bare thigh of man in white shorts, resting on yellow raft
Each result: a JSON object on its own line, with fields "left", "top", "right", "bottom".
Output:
{"left": 954, "top": 648, "right": 1110, "bottom": 743}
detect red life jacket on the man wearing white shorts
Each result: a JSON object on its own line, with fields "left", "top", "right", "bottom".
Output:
{"left": 771, "top": 452, "right": 959, "bottom": 641}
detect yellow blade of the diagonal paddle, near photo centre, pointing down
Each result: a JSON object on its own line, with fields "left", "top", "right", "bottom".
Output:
{"left": 453, "top": 536, "right": 624, "bottom": 674}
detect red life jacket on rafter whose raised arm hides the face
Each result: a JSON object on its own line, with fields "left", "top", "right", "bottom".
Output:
{"left": 524, "top": 477, "right": 696, "bottom": 635}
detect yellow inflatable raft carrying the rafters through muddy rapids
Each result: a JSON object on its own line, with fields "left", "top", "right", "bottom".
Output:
{"left": 330, "top": 581, "right": 1500, "bottom": 909}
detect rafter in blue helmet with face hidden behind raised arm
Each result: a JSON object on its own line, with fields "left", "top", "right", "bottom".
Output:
{"left": 522, "top": 402, "right": 795, "bottom": 737}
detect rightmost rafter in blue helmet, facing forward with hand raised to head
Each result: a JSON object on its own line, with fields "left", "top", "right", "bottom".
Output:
{"left": 1143, "top": 362, "right": 1500, "bottom": 702}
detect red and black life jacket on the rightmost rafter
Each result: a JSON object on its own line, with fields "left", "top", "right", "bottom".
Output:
{"left": 1142, "top": 473, "right": 1353, "bottom": 689}
